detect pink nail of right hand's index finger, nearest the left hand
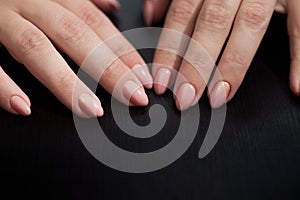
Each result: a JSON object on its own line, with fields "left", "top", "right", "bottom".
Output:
{"left": 154, "top": 68, "right": 171, "bottom": 95}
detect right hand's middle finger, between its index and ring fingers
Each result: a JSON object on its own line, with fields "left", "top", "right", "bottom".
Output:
{"left": 174, "top": 0, "right": 240, "bottom": 110}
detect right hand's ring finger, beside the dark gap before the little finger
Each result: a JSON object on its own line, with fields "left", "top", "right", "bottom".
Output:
{"left": 208, "top": 0, "right": 276, "bottom": 108}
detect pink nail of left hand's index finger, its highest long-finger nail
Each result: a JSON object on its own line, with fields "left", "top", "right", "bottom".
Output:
{"left": 132, "top": 65, "right": 153, "bottom": 89}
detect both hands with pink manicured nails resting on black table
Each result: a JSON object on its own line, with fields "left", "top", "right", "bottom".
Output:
{"left": 0, "top": 0, "right": 300, "bottom": 117}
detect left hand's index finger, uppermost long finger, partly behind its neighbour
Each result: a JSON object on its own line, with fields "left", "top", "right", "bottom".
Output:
{"left": 57, "top": 0, "right": 153, "bottom": 89}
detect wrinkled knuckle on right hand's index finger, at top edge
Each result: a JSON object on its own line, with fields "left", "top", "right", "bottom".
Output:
{"left": 168, "top": 0, "right": 196, "bottom": 24}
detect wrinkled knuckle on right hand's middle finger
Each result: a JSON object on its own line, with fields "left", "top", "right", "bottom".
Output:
{"left": 199, "top": 3, "right": 230, "bottom": 30}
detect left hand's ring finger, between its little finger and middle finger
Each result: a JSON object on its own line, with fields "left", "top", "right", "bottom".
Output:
{"left": 0, "top": 12, "right": 103, "bottom": 117}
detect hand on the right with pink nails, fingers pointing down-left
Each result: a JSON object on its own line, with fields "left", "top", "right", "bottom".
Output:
{"left": 144, "top": 0, "right": 300, "bottom": 110}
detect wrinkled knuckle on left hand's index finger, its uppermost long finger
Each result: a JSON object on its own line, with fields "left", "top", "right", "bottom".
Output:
{"left": 79, "top": 6, "right": 104, "bottom": 29}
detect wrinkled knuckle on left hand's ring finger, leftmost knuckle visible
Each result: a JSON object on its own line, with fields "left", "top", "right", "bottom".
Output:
{"left": 16, "top": 29, "right": 47, "bottom": 55}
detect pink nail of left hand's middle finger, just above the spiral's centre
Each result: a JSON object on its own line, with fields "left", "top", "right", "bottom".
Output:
{"left": 123, "top": 81, "right": 149, "bottom": 106}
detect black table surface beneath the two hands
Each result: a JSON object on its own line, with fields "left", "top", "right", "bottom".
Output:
{"left": 0, "top": 0, "right": 300, "bottom": 199}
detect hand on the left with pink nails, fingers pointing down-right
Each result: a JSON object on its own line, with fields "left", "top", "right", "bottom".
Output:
{"left": 0, "top": 0, "right": 152, "bottom": 117}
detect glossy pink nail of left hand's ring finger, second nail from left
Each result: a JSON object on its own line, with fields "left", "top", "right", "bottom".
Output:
{"left": 78, "top": 94, "right": 104, "bottom": 117}
